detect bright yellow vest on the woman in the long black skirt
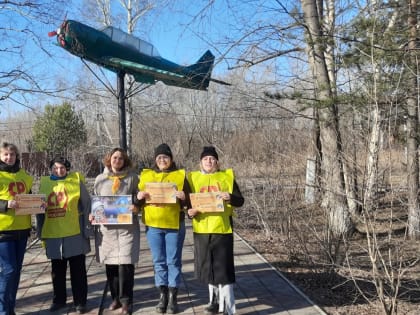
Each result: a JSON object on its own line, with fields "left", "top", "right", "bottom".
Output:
{"left": 187, "top": 169, "right": 235, "bottom": 234}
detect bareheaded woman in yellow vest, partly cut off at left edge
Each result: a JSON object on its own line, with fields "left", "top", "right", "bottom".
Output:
{"left": 0, "top": 142, "right": 33, "bottom": 315}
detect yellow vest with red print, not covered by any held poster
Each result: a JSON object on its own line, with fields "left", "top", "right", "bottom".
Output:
{"left": 39, "top": 172, "right": 83, "bottom": 238}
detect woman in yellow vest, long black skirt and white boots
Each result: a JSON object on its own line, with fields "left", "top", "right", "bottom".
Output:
{"left": 187, "top": 146, "right": 244, "bottom": 315}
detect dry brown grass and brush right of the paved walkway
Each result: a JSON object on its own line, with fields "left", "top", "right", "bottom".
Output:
{"left": 235, "top": 180, "right": 420, "bottom": 315}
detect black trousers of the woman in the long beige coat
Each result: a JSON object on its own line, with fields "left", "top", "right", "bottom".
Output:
{"left": 105, "top": 264, "right": 134, "bottom": 305}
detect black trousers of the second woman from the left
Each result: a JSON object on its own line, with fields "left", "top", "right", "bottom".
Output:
{"left": 51, "top": 255, "right": 87, "bottom": 306}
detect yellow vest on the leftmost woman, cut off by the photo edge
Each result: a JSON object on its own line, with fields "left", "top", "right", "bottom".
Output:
{"left": 0, "top": 169, "right": 33, "bottom": 231}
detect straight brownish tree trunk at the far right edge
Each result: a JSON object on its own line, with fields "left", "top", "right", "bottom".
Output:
{"left": 407, "top": 0, "right": 420, "bottom": 239}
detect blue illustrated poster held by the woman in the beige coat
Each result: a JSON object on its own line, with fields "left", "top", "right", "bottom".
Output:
{"left": 91, "top": 195, "right": 133, "bottom": 225}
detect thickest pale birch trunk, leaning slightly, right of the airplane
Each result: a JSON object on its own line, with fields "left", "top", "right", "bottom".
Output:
{"left": 301, "top": 0, "right": 353, "bottom": 236}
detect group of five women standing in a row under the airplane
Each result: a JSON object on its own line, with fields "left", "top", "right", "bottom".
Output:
{"left": 0, "top": 143, "right": 244, "bottom": 315}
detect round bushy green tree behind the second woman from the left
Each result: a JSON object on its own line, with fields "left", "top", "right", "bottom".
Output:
{"left": 32, "top": 103, "right": 87, "bottom": 155}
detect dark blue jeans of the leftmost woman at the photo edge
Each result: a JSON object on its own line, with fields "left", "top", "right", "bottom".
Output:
{"left": 0, "top": 238, "right": 28, "bottom": 315}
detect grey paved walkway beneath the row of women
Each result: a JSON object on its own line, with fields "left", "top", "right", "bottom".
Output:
{"left": 16, "top": 226, "right": 325, "bottom": 315}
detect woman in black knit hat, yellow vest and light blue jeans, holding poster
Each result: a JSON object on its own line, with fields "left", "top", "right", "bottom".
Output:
{"left": 137, "top": 143, "right": 190, "bottom": 314}
